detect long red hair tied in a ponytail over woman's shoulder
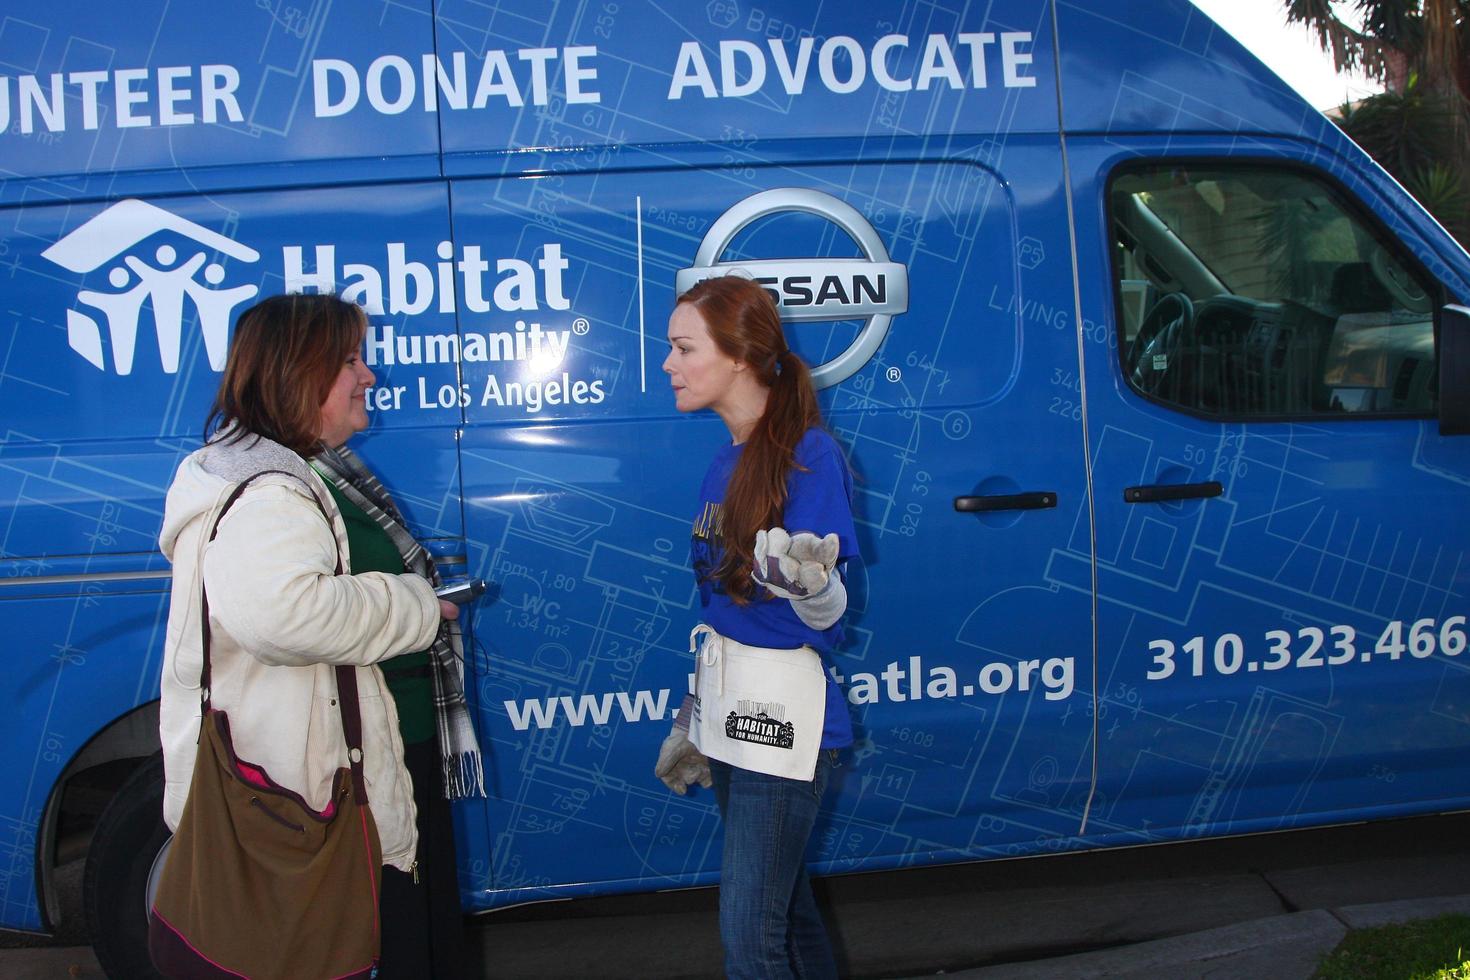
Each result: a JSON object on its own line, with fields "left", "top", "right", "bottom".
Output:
{"left": 678, "top": 276, "right": 822, "bottom": 605}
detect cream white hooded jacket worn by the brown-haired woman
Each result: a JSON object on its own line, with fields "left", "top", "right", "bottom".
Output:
{"left": 159, "top": 436, "right": 440, "bottom": 871}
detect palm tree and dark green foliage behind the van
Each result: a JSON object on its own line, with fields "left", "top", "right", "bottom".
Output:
{"left": 1283, "top": 0, "right": 1470, "bottom": 247}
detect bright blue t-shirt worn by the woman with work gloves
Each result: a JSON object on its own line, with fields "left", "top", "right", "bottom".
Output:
{"left": 691, "top": 429, "right": 857, "bottom": 748}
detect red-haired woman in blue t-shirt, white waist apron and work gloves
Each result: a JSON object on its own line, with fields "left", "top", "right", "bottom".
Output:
{"left": 656, "top": 276, "right": 857, "bottom": 980}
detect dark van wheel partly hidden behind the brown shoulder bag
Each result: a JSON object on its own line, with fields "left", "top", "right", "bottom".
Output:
{"left": 82, "top": 755, "right": 169, "bottom": 977}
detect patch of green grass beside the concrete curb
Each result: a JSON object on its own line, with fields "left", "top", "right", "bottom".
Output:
{"left": 1314, "top": 915, "right": 1470, "bottom": 980}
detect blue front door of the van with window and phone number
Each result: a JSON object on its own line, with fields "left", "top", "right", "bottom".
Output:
{"left": 1072, "top": 141, "right": 1470, "bottom": 840}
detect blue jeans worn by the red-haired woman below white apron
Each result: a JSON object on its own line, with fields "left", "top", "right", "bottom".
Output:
{"left": 710, "top": 749, "right": 836, "bottom": 980}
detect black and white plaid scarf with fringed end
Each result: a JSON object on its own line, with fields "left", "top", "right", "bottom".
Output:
{"left": 312, "top": 447, "right": 485, "bottom": 799}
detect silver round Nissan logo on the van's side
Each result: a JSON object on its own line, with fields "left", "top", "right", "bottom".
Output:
{"left": 675, "top": 187, "right": 908, "bottom": 388}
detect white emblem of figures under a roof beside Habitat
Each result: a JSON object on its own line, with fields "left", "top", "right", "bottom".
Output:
{"left": 41, "top": 200, "right": 260, "bottom": 375}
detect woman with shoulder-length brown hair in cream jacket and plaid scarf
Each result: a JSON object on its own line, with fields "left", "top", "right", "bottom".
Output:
{"left": 156, "top": 295, "right": 482, "bottom": 977}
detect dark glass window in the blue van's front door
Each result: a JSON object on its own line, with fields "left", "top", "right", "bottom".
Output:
{"left": 1110, "top": 165, "right": 1436, "bottom": 419}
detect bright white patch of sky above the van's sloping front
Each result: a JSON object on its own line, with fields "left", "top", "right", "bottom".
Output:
{"left": 1192, "top": 0, "right": 1382, "bottom": 109}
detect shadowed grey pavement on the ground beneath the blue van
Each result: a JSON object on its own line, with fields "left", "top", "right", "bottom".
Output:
{"left": 0, "top": 814, "right": 1470, "bottom": 980}
